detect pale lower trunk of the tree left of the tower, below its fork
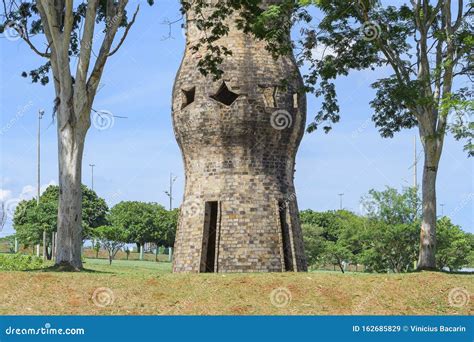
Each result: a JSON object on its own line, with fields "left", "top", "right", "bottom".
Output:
{"left": 56, "top": 121, "right": 86, "bottom": 270}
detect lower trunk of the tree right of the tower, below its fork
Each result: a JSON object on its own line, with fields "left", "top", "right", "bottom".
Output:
{"left": 417, "top": 137, "right": 441, "bottom": 270}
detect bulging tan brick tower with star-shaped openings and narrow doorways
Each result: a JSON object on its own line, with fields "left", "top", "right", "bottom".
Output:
{"left": 173, "top": 1, "right": 307, "bottom": 272}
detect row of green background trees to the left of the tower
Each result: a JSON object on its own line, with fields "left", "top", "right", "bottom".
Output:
{"left": 13, "top": 185, "right": 178, "bottom": 260}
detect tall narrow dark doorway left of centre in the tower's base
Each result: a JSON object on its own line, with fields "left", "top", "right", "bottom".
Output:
{"left": 201, "top": 202, "right": 218, "bottom": 273}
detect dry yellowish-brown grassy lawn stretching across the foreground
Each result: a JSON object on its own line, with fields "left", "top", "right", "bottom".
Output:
{"left": 0, "top": 259, "right": 474, "bottom": 315}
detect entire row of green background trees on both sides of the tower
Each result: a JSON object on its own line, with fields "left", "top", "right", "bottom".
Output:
{"left": 9, "top": 185, "right": 474, "bottom": 273}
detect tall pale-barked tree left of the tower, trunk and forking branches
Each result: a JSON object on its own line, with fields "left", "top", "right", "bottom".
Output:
{"left": 0, "top": 0, "right": 152, "bottom": 270}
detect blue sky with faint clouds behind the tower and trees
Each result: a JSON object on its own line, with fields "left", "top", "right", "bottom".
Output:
{"left": 0, "top": 0, "right": 474, "bottom": 236}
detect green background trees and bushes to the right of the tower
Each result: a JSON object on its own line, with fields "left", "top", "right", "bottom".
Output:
{"left": 300, "top": 188, "right": 474, "bottom": 273}
